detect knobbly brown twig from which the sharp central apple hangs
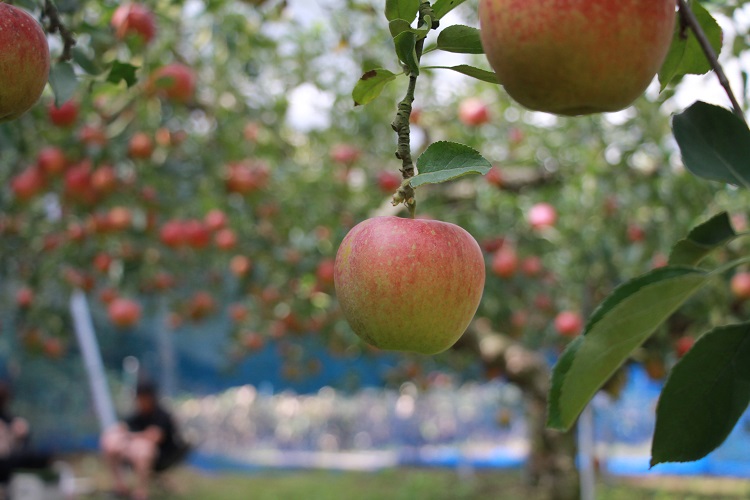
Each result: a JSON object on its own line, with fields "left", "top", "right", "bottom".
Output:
{"left": 391, "top": 0, "right": 437, "bottom": 219}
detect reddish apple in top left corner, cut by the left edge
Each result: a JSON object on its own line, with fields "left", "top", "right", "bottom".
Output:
{"left": 0, "top": 2, "right": 50, "bottom": 123}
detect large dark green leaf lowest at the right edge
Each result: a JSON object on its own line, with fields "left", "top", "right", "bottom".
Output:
{"left": 651, "top": 323, "right": 750, "bottom": 467}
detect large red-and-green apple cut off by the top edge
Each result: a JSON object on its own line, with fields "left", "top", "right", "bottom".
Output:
{"left": 479, "top": 0, "right": 676, "bottom": 116}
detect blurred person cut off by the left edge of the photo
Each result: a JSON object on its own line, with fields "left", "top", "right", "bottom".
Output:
{"left": 0, "top": 381, "right": 52, "bottom": 489}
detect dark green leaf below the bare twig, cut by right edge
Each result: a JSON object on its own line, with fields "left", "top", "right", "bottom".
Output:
{"left": 672, "top": 101, "right": 750, "bottom": 187}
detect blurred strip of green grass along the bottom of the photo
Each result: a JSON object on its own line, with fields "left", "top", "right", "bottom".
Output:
{"left": 58, "top": 456, "right": 750, "bottom": 500}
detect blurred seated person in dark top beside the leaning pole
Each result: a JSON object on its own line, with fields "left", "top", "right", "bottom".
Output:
{"left": 100, "top": 382, "right": 187, "bottom": 500}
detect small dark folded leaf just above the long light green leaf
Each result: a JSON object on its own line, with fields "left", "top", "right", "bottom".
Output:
{"left": 669, "top": 212, "right": 737, "bottom": 266}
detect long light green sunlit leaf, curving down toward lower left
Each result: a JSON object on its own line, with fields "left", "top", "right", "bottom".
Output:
{"left": 547, "top": 267, "right": 709, "bottom": 430}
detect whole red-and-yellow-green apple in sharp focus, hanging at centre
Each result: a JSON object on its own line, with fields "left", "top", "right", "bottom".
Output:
{"left": 334, "top": 217, "right": 485, "bottom": 354}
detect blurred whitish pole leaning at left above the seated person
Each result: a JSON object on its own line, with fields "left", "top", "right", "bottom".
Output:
{"left": 70, "top": 290, "right": 117, "bottom": 431}
